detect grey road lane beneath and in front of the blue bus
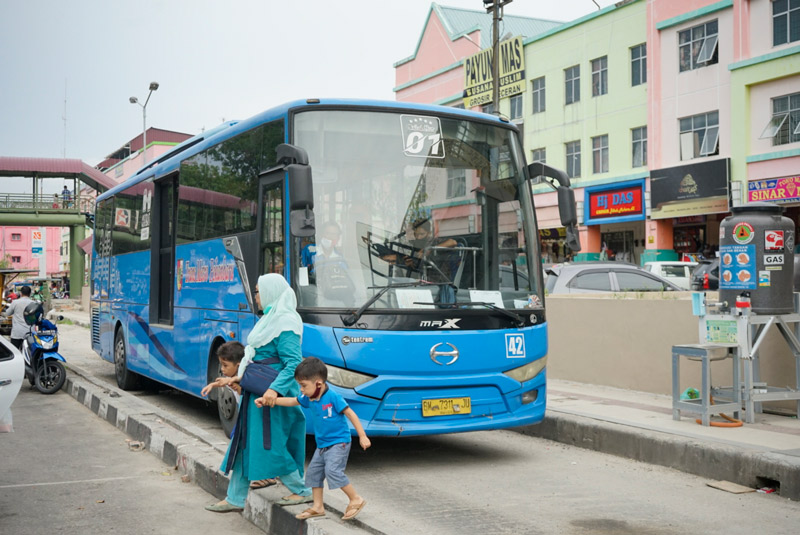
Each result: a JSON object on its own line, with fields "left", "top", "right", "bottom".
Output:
{"left": 53, "top": 326, "right": 800, "bottom": 535}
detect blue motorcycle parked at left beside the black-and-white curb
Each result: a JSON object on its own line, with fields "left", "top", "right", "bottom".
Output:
{"left": 22, "top": 302, "right": 67, "bottom": 394}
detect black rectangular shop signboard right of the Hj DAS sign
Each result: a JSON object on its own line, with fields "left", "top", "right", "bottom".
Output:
{"left": 650, "top": 158, "right": 730, "bottom": 219}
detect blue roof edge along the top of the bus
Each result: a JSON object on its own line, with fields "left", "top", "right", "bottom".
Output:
{"left": 97, "top": 99, "right": 513, "bottom": 202}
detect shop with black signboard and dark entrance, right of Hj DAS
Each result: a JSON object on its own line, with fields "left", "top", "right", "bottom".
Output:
{"left": 648, "top": 158, "right": 730, "bottom": 260}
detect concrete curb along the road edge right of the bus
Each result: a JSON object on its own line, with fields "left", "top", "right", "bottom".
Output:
{"left": 514, "top": 409, "right": 800, "bottom": 500}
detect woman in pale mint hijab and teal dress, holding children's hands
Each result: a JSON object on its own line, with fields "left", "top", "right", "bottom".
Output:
{"left": 206, "top": 273, "right": 312, "bottom": 513}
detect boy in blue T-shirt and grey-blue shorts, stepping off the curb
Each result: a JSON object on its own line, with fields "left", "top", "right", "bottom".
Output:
{"left": 256, "top": 357, "right": 371, "bottom": 520}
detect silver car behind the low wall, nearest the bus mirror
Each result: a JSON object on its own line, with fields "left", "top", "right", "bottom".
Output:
{"left": 545, "top": 262, "right": 682, "bottom": 294}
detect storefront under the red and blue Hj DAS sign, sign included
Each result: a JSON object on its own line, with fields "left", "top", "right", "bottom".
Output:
{"left": 584, "top": 179, "right": 645, "bottom": 263}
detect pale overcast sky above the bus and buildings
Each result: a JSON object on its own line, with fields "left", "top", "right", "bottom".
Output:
{"left": 0, "top": 0, "right": 614, "bottom": 165}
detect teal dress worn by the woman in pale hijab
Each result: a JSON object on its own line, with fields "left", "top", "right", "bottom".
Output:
{"left": 221, "top": 331, "right": 306, "bottom": 481}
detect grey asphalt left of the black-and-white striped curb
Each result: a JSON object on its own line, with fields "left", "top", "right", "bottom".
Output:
{"left": 0, "top": 388, "right": 263, "bottom": 535}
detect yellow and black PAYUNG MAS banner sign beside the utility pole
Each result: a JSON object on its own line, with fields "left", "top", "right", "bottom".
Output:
{"left": 464, "top": 37, "right": 525, "bottom": 109}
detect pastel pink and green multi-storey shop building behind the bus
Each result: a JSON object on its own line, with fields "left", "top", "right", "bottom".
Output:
{"left": 395, "top": 0, "right": 800, "bottom": 263}
